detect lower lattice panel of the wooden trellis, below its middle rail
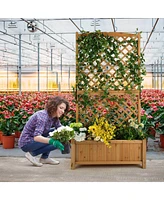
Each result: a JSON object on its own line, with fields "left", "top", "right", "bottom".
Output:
{"left": 77, "top": 90, "right": 140, "bottom": 125}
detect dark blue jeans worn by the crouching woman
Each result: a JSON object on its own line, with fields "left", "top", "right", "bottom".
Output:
{"left": 21, "top": 129, "right": 57, "bottom": 159}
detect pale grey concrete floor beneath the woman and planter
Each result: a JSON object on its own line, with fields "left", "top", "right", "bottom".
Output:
{"left": 0, "top": 139, "right": 164, "bottom": 182}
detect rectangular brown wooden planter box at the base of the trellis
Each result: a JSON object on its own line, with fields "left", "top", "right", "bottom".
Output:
{"left": 71, "top": 139, "right": 146, "bottom": 169}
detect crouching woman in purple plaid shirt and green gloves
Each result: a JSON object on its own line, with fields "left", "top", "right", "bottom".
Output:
{"left": 18, "top": 96, "right": 69, "bottom": 167}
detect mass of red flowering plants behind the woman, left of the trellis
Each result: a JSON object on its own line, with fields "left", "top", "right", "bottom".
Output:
{"left": 0, "top": 92, "right": 76, "bottom": 134}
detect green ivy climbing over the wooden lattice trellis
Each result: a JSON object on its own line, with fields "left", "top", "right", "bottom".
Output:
{"left": 73, "top": 31, "right": 146, "bottom": 126}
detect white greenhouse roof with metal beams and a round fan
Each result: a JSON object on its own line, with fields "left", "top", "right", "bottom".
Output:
{"left": 0, "top": 1, "right": 164, "bottom": 67}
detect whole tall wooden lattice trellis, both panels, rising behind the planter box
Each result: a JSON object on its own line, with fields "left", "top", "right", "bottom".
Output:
{"left": 76, "top": 33, "right": 140, "bottom": 124}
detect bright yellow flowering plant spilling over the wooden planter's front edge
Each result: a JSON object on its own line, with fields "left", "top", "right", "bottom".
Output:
{"left": 88, "top": 117, "right": 116, "bottom": 147}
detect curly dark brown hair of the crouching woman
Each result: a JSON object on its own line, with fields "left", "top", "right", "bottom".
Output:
{"left": 45, "top": 96, "right": 69, "bottom": 117}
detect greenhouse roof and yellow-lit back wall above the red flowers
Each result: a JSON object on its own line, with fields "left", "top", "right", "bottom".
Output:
{"left": 0, "top": 18, "right": 164, "bottom": 93}
